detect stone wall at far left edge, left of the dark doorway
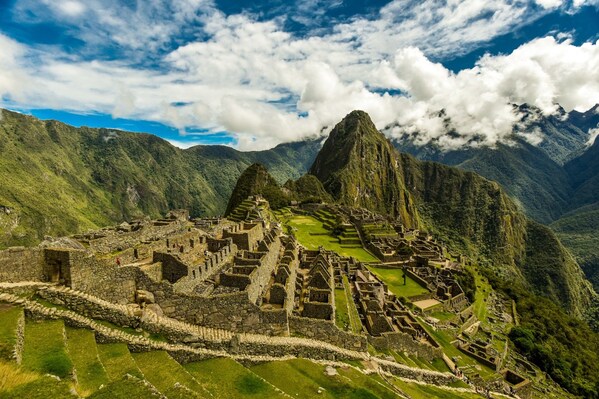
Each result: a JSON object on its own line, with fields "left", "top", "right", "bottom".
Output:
{"left": 0, "top": 247, "right": 44, "bottom": 283}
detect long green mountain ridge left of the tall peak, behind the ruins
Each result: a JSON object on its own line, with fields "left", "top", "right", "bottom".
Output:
{"left": 0, "top": 110, "right": 320, "bottom": 247}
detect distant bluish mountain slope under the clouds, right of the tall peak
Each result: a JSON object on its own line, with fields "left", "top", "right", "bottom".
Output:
{"left": 394, "top": 104, "right": 588, "bottom": 223}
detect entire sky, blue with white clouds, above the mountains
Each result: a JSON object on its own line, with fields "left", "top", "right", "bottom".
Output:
{"left": 0, "top": 0, "right": 599, "bottom": 149}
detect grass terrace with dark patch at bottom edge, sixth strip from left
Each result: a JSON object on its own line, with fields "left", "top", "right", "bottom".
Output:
{"left": 185, "top": 358, "right": 284, "bottom": 399}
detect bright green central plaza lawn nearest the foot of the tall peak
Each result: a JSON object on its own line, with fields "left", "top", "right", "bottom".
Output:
{"left": 283, "top": 215, "right": 378, "bottom": 262}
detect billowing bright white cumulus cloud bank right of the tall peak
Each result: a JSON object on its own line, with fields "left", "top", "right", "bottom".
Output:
{"left": 389, "top": 37, "right": 599, "bottom": 148}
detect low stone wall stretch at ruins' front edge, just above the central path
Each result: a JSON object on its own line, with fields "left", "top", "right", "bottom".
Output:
{"left": 289, "top": 316, "right": 368, "bottom": 351}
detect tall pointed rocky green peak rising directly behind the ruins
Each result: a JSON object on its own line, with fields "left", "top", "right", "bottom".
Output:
{"left": 310, "top": 111, "right": 418, "bottom": 226}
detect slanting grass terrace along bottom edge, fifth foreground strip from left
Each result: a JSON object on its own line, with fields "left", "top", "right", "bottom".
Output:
{"left": 132, "top": 351, "right": 210, "bottom": 398}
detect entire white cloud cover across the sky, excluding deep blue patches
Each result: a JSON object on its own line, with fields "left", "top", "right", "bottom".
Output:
{"left": 0, "top": 0, "right": 599, "bottom": 149}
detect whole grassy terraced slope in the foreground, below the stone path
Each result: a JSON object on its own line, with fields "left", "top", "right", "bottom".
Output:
{"left": 0, "top": 294, "right": 494, "bottom": 399}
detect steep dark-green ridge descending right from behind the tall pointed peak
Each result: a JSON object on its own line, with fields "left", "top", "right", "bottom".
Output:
{"left": 399, "top": 154, "right": 593, "bottom": 315}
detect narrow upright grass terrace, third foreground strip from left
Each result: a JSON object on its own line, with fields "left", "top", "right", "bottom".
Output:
{"left": 66, "top": 327, "right": 109, "bottom": 396}
